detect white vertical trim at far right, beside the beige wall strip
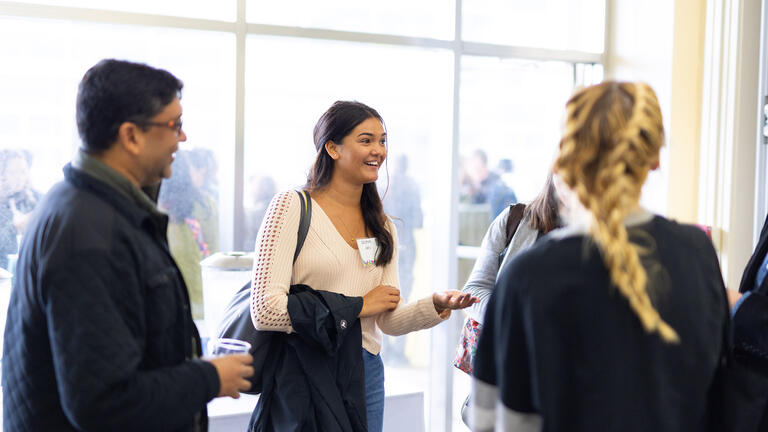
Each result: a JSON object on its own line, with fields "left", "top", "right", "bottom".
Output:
{"left": 698, "top": 0, "right": 762, "bottom": 288}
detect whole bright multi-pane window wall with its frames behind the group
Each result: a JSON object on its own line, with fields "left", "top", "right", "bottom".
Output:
{"left": 0, "top": 0, "right": 608, "bottom": 432}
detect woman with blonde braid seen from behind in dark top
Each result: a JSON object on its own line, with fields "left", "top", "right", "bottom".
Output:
{"left": 471, "top": 82, "right": 728, "bottom": 432}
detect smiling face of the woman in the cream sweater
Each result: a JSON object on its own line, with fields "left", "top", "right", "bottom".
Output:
{"left": 325, "top": 117, "right": 387, "bottom": 185}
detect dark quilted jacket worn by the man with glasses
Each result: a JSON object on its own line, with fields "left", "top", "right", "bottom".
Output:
{"left": 2, "top": 166, "right": 219, "bottom": 431}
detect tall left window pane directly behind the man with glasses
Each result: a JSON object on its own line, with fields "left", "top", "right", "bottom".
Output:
{"left": 0, "top": 18, "right": 235, "bottom": 324}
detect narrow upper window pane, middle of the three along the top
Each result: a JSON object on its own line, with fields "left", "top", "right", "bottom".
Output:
{"left": 246, "top": 0, "right": 454, "bottom": 39}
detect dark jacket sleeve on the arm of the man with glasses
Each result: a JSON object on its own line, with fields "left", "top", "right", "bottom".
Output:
{"left": 43, "top": 253, "right": 219, "bottom": 431}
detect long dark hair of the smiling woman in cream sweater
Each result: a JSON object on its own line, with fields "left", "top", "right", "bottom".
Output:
{"left": 305, "top": 101, "right": 394, "bottom": 266}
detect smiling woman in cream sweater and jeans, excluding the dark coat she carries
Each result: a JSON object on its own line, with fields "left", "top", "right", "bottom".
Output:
{"left": 251, "top": 101, "right": 477, "bottom": 432}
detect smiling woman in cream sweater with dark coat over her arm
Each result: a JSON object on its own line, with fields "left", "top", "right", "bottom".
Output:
{"left": 251, "top": 101, "right": 477, "bottom": 432}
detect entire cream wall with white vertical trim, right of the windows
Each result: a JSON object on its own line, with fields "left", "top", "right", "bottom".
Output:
{"left": 606, "top": 0, "right": 761, "bottom": 287}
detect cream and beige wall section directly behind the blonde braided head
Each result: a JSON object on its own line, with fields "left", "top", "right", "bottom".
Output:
{"left": 607, "top": 0, "right": 706, "bottom": 222}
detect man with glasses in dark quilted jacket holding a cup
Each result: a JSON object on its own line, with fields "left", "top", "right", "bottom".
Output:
{"left": 2, "top": 60, "right": 253, "bottom": 431}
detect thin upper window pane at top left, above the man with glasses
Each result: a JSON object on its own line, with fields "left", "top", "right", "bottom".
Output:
{"left": 11, "top": 0, "right": 237, "bottom": 22}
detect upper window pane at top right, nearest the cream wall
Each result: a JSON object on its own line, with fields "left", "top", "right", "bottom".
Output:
{"left": 462, "top": 0, "right": 605, "bottom": 53}
